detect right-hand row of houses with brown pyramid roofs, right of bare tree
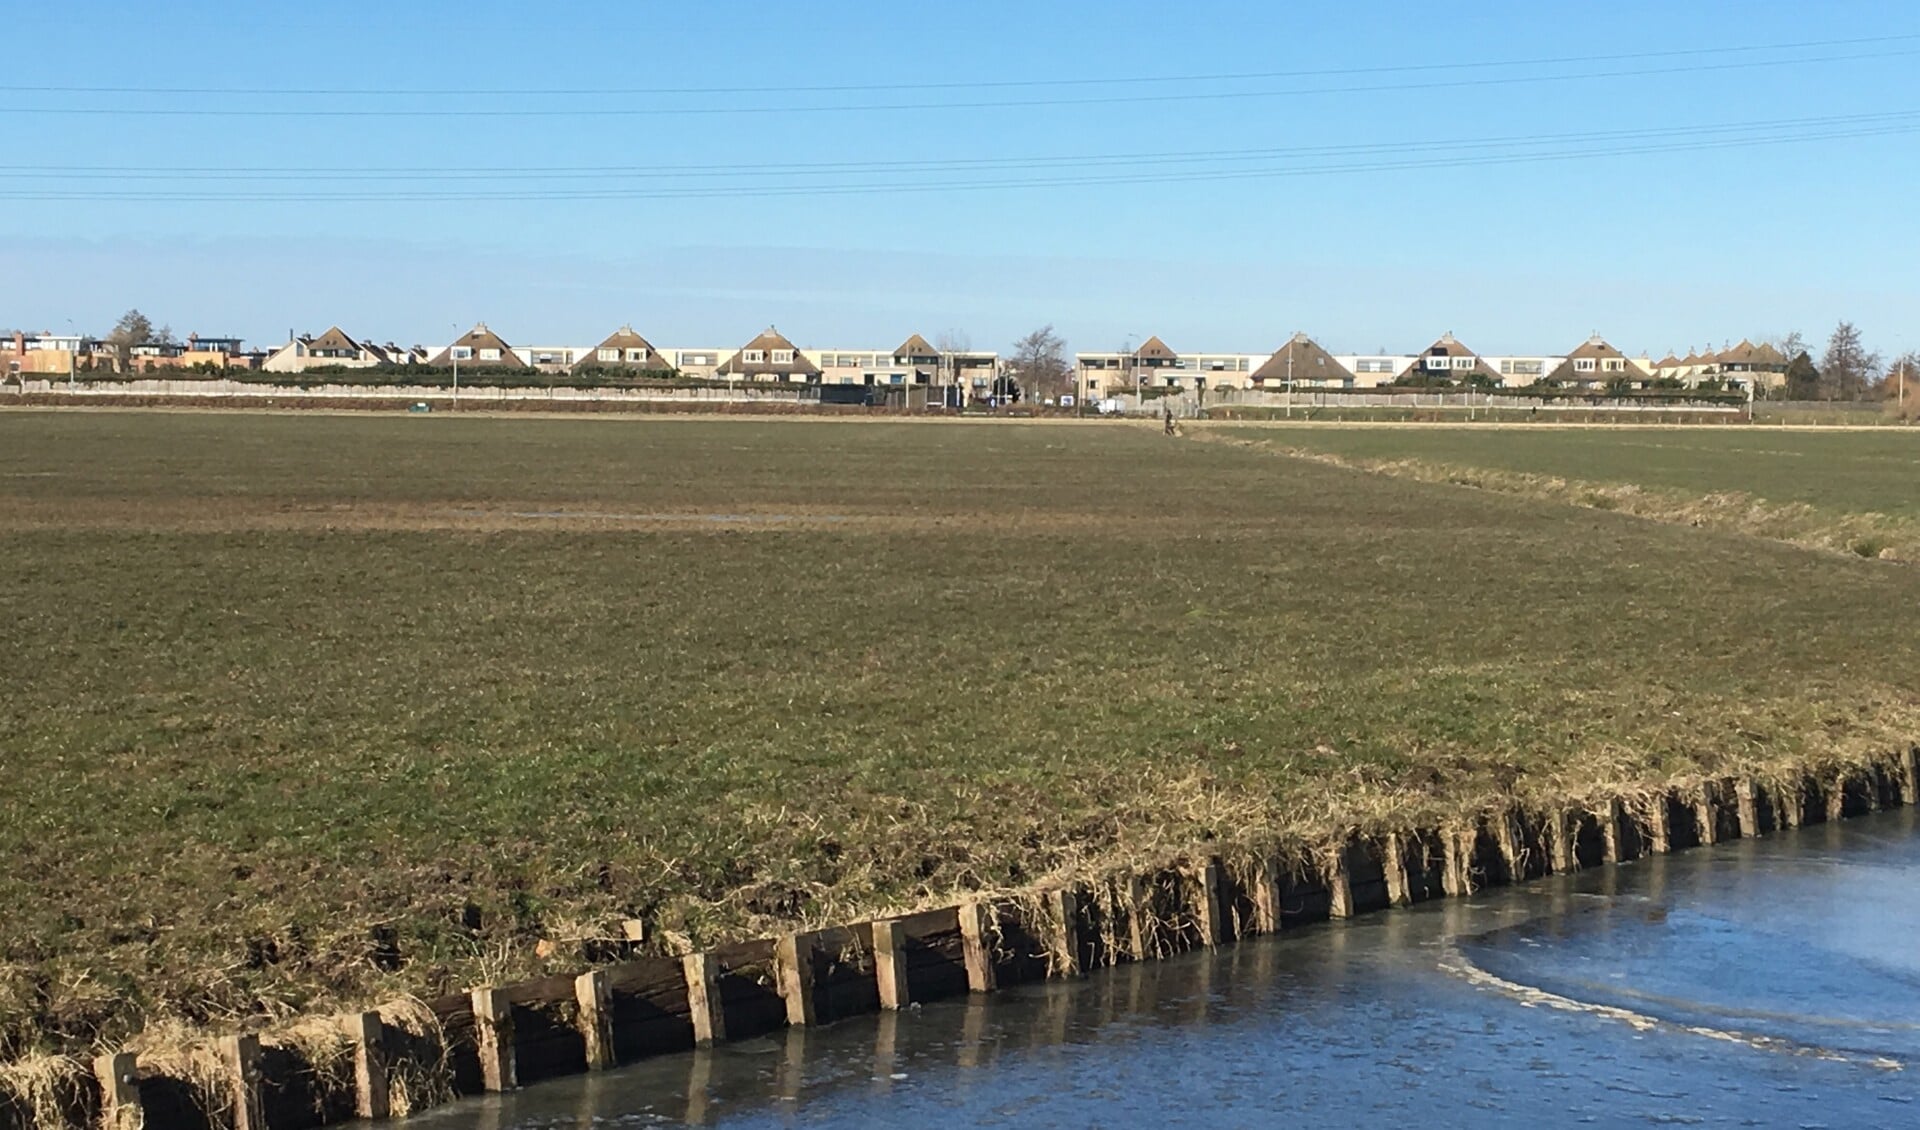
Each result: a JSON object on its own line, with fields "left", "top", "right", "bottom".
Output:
{"left": 1073, "top": 332, "right": 1789, "bottom": 397}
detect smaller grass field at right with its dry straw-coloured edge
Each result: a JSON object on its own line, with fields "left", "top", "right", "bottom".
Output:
{"left": 1198, "top": 426, "right": 1920, "bottom": 560}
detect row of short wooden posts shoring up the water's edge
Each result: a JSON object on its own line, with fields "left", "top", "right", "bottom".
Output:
{"left": 74, "top": 746, "right": 1920, "bottom": 1130}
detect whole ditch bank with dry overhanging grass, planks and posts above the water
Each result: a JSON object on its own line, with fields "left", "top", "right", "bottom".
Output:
{"left": 0, "top": 748, "right": 1920, "bottom": 1130}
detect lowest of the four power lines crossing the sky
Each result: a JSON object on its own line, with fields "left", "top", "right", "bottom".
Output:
{"left": 0, "top": 123, "right": 1920, "bottom": 203}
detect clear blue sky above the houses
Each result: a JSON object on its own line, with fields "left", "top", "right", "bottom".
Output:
{"left": 0, "top": 0, "right": 1920, "bottom": 355}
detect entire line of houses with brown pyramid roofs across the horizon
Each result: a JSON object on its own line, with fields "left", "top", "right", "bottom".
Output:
{"left": 0, "top": 322, "right": 1788, "bottom": 399}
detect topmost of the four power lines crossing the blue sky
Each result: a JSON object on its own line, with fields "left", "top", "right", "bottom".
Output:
{"left": 0, "top": 33, "right": 1920, "bottom": 98}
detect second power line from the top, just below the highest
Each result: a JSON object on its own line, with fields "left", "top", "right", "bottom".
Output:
{"left": 0, "top": 48, "right": 1920, "bottom": 119}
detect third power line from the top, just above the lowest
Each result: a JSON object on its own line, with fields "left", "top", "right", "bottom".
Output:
{"left": 0, "top": 109, "right": 1920, "bottom": 182}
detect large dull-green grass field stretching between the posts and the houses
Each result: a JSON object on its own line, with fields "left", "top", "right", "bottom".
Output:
{"left": 0, "top": 412, "right": 1920, "bottom": 1051}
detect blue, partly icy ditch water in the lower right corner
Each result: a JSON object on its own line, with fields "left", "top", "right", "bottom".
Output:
{"left": 420, "top": 810, "right": 1920, "bottom": 1130}
